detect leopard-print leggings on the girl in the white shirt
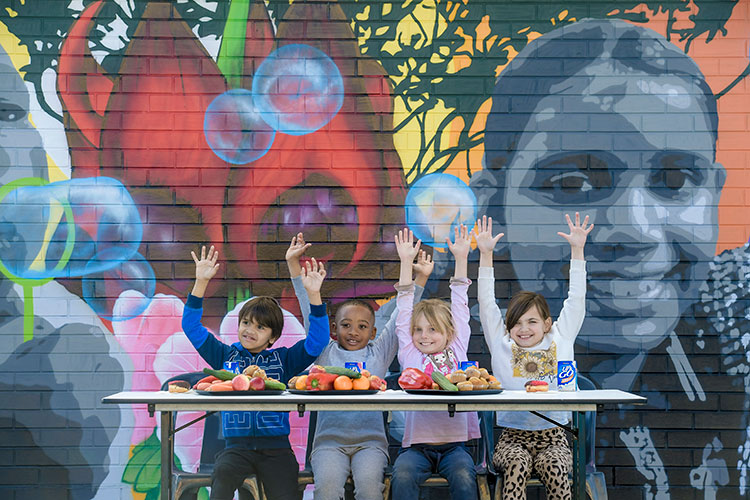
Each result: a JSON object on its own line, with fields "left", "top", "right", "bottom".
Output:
{"left": 492, "top": 427, "right": 573, "bottom": 500}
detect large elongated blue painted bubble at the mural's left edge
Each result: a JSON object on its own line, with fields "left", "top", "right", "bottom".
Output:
{"left": 0, "top": 177, "right": 143, "bottom": 280}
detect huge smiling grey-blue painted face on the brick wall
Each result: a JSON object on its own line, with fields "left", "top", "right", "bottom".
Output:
{"left": 489, "top": 61, "right": 724, "bottom": 351}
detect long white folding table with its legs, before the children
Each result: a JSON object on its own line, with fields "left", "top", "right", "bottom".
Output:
{"left": 102, "top": 389, "right": 646, "bottom": 500}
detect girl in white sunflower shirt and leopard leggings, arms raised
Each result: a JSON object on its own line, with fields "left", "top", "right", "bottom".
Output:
{"left": 475, "top": 212, "right": 594, "bottom": 500}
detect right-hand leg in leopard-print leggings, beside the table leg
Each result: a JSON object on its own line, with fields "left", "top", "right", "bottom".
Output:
{"left": 534, "top": 427, "right": 573, "bottom": 500}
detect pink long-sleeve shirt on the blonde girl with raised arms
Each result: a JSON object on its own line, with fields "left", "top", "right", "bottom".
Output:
{"left": 396, "top": 278, "right": 479, "bottom": 448}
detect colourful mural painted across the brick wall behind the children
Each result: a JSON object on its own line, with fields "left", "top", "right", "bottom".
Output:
{"left": 0, "top": 0, "right": 750, "bottom": 500}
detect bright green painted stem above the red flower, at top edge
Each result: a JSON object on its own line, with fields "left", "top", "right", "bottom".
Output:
{"left": 216, "top": 0, "right": 250, "bottom": 88}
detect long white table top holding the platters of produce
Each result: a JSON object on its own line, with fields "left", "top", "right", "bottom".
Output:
{"left": 102, "top": 389, "right": 646, "bottom": 411}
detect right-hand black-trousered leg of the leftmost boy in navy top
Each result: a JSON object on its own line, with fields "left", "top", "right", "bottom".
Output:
{"left": 255, "top": 448, "right": 302, "bottom": 500}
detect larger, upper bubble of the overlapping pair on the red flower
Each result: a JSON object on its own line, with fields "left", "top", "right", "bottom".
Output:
{"left": 253, "top": 44, "right": 344, "bottom": 135}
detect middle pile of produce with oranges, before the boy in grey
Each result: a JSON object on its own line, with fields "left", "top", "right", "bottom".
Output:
{"left": 287, "top": 365, "right": 386, "bottom": 391}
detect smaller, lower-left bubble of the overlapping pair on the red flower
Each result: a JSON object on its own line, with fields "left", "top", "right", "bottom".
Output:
{"left": 203, "top": 89, "right": 276, "bottom": 165}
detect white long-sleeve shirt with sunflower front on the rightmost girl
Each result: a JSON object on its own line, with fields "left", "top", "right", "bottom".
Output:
{"left": 477, "top": 260, "right": 586, "bottom": 430}
